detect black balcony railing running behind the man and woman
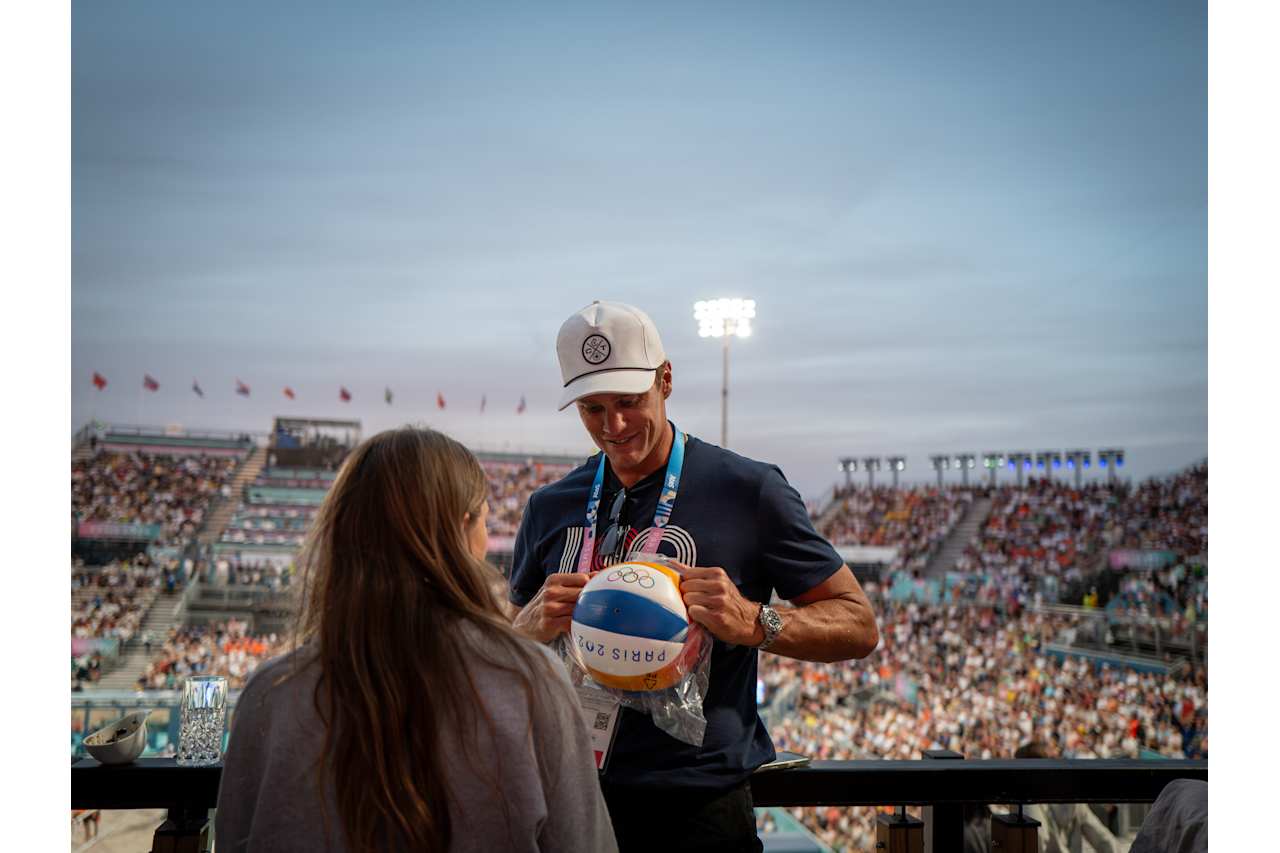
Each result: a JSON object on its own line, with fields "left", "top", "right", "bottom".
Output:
{"left": 72, "top": 751, "right": 1208, "bottom": 853}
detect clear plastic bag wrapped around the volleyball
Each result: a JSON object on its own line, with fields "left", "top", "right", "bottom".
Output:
{"left": 553, "top": 553, "right": 714, "bottom": 747}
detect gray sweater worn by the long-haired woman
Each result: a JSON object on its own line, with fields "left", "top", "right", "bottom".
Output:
{"left": 214, "top": 629, "right": 617, "bottom": 853}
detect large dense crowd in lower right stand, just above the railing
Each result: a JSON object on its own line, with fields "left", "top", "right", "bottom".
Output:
{"left": 760, "top": 584, "right": 1208, "bottom": 850}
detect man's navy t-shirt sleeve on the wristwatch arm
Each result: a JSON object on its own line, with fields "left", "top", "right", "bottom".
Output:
{"left": 755, "top": 466, "right": 845, "bottom": 601}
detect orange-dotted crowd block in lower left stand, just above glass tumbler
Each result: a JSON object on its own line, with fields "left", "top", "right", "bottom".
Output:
{"left": 138, "top": 619, "right": 284, "bottom": 690}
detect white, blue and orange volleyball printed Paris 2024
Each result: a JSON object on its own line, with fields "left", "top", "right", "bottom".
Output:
{"left": 571, "top": 562, "right": 701, "bottom": 690}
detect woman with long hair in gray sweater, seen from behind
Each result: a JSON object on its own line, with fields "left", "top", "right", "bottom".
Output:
{"left": 215, "top": 428, "right": 617, "bottom": 853}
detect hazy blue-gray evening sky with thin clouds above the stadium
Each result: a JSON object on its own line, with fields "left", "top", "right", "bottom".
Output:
{"left": 72, "top": 3, "right": 1207, "bottom": 496}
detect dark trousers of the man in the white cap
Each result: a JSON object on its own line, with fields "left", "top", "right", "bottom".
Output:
{"left": 600, "top": 781, "right": 764, "bottom": 853}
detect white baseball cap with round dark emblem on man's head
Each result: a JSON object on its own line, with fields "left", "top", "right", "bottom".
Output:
{"left": 556, "top": 301, "right": 667, "bottom": 411}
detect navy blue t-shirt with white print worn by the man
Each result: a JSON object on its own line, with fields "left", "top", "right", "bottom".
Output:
{"left": 509, "top": 437, "right": 844, "bottom": 789}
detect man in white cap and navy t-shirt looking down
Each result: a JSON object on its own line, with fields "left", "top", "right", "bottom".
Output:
{"left": 509, "top": 302, "right": 879, "bottom": 853}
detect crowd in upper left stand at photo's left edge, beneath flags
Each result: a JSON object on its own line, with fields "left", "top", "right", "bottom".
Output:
{"left": 72, "top": 452, "right": 239, "bottom": 544}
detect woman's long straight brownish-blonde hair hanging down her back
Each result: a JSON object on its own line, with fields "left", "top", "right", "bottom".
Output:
{"left": 298, "top": 428, "right": 552, "bottom": 853}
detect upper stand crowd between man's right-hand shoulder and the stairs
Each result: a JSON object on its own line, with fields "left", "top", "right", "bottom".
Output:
{"left": 818, "top": 487, "right": 974, "bottom": 571}
